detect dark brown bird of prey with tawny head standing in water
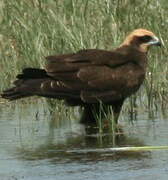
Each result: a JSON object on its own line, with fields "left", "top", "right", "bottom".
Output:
{"left": 2, "top": 29, "right": 161, "bottom": 122}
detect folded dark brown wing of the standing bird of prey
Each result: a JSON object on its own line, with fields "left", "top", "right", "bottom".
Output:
{"left": 43, "top": 48, "right": 144, "bottom": 103}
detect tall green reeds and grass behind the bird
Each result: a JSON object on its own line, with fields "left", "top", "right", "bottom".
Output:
{"left": 0, "top": 0, "right": 168, "bottom": 129}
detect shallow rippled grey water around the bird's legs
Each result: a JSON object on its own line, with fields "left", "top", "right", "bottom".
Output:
{"left": 0, "top": 101, "right": 168, "bottom": 180}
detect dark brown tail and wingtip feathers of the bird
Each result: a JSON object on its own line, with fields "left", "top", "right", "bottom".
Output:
{"left": 1, "top": 68, "right": 80, "bottom": 100}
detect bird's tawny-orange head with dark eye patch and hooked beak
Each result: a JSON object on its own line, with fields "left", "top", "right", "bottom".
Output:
{"left": 122, "top": 29, "right": 161, "bottom": 52}
